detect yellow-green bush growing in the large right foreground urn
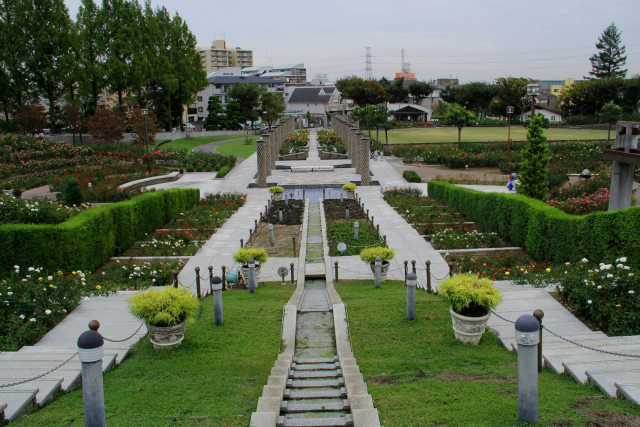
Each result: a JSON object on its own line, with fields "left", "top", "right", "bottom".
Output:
{"left": 438, "top": 273, "right": 502, "bottom": 317}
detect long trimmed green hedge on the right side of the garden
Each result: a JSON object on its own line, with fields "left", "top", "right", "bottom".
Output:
{"left": 429, "top": 181, "right": 640, "bottom": 268}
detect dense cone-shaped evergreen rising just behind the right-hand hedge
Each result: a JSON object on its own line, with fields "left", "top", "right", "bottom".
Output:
{"left": 518, "top": 116, "right": 549, "bottom": 200}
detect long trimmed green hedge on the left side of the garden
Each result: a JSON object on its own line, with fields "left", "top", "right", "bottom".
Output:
{"left": 0, "top": 189, "right": 200, "bottom": 273}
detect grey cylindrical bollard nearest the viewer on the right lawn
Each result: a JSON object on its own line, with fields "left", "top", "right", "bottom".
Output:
{"left": 516, "top": 314, "right": 540, "bottom": 422}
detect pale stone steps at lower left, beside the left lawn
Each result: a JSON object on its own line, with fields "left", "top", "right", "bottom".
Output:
{"left": 0, "top": 292, "right": 146, "bottom": 423}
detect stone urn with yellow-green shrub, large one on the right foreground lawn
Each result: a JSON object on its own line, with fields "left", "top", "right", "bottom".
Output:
{"left": 439, "top": 274, "right": 502, "bottom": 345}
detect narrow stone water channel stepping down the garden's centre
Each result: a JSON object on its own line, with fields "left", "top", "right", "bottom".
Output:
{"left": 277, "top": 202, "right": 353, "bottom": 426}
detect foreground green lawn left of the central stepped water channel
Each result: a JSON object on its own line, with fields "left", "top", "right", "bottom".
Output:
{"left": 12, "top": 283, "right": 294, "bottom": 426}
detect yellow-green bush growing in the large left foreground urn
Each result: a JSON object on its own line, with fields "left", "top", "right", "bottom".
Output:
{"left": 129, "top": 287, "right": 199, "bottom": 326}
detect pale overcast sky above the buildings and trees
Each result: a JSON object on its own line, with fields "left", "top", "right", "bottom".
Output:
{"left": 65, "top": 0, "right": 640, "bottom": 82}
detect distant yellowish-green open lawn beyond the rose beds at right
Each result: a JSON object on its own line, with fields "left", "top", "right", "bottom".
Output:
{"left": 382, "top": 126, "right": 607, "bottom": 144}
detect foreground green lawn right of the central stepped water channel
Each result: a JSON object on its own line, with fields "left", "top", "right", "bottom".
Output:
{"left": 336, "top": 281, "right": 640, "bottom": 427}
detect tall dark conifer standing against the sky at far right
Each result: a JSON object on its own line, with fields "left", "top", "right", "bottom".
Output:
{"left": 589, "top": 22, "right": 627, "bottom": 79}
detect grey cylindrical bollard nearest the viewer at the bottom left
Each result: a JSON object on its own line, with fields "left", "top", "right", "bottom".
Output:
{"left": 77, "top": 320, "right": 107, "bottom": 427}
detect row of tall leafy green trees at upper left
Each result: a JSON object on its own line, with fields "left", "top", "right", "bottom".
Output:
{"left": 0, "top": 0, "right": 207, "bottom": 131}
